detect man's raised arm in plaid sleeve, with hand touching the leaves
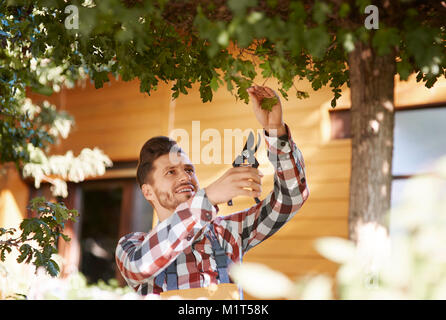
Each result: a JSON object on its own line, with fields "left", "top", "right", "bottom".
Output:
{"left": 211, "top": 86, "right": 309, "bottom": 253}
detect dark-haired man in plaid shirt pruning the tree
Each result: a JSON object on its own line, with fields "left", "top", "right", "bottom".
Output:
{"left": 116, "top": 86, "right": 309, "bottom": 295}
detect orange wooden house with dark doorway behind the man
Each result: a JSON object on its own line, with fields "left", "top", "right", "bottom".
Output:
{"left": 0, "top": 72, "right": 446, "bottom": 298}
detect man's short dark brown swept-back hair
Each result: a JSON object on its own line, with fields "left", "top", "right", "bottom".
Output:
{"left": 136, "top": 136, "right": 183, "bottom": 188}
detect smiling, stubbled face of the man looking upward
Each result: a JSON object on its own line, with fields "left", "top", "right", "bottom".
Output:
{"left": 143, "top": 153, "right": 199, "bottom": 211}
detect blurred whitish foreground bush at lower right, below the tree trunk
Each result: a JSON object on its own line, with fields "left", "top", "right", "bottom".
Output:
{"left": 231, "top": 157, "right": 446, "bottom": 300}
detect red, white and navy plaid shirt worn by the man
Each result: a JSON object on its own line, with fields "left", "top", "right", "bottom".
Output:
{"left": 115, "top": 126, "right": 309, "bottom": 296}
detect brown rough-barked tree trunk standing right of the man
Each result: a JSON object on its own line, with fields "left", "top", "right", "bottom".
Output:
{"left": 349, "top": 42, "right": 396, "bottom": 242}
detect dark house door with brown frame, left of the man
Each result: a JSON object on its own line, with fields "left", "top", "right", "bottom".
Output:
{"left": 79, "top": 178, "right": 153, "bottom": 284}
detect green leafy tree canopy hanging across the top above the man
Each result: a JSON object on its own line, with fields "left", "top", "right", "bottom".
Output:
{"left": 0, "top": 0, "right": 446, "bottom": 161}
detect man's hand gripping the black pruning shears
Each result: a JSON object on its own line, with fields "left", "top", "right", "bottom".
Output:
{"left": 204, "top": 167, "right": 263, "bottom": 205}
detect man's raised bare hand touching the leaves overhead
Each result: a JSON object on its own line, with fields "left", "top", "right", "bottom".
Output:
{"left": 246, "top": 86, "right": 286, "bottom": 136}
